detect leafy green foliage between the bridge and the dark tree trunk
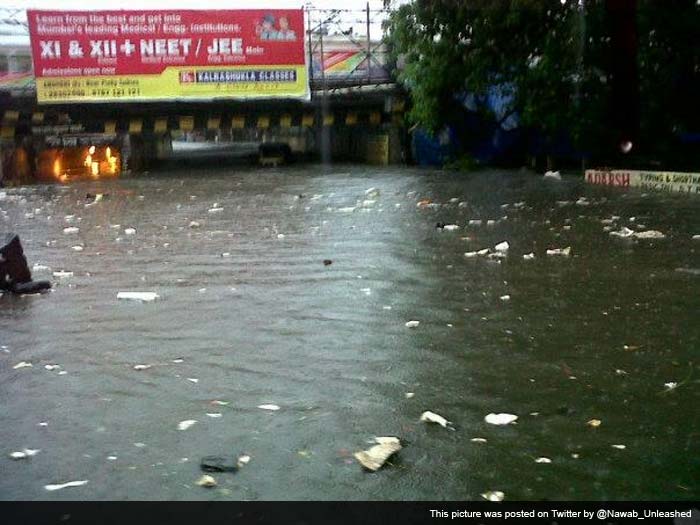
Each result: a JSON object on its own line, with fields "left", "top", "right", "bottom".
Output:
{"left": 388, "top": 0, "right": 609, "bottom": 158}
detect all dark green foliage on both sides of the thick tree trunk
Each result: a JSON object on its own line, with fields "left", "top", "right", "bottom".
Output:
{"left": 388, "top": 0, "right": 700, "bottom": 162}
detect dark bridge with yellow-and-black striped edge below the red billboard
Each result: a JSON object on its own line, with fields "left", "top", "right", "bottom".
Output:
{"left": 0, "top": 4, "right": 406, "bottom": 181}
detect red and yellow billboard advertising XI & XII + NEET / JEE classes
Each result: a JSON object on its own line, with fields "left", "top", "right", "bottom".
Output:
{"left": 27, "top": 9, "right": 309, "bottom": 103}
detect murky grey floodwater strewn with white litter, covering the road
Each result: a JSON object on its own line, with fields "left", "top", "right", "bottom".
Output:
{"left": 0, "top": 166, "right": 700, "bottom": 500}
